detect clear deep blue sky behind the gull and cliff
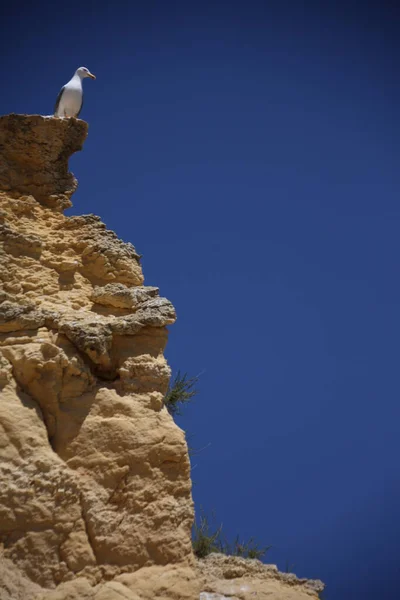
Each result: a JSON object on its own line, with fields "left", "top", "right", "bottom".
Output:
{"left": 0, "top": 0, "right": 400, "bottom": 600}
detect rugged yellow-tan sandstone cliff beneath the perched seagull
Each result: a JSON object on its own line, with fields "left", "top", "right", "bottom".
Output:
{"left": 0, "top": 115, "right": 317, "bottom": 600}
